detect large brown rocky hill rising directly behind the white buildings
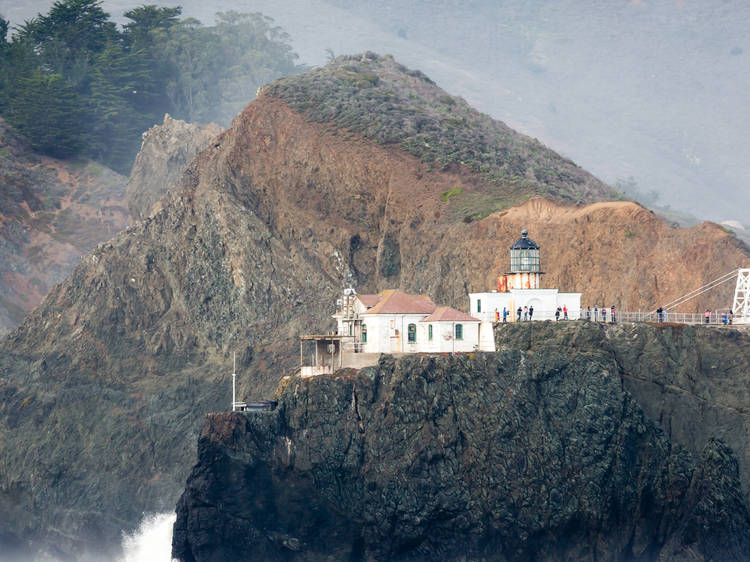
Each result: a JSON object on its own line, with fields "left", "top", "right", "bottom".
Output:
{"left": 0, "top": 54, "right": 748, "bottom": 557}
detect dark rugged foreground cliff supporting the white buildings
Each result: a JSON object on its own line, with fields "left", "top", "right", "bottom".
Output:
{"left": 173, "top": 323, "right": 750, "bottom": 561}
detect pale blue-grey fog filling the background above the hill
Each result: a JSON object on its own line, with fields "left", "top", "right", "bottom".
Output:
{"left": 0, "top": 0, "right": 750, "bottom": 226}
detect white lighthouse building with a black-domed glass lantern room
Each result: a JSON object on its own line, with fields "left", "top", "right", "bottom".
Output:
{"left": 469, "top": 230, "right": 581, "bottom": 322}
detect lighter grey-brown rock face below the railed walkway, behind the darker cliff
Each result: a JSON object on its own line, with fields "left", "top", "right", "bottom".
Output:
{"left": 496, "top": 322, "right": 750, "bottom": 498}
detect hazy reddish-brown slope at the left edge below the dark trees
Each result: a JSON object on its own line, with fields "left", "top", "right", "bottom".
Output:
{"left": 0, "top": 119, "right": 130, "bottom": 334}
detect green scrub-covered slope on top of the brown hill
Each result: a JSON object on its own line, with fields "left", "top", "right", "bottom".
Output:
{"left": 266, "top": 53, "right": 621, "bottom": 218}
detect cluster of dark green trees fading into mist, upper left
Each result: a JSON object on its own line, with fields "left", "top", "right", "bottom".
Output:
{"left": 0, "top": 0, "right": 301, "bottom": 173}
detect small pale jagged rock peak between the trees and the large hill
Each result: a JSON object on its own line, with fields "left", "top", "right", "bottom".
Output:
{"left": 126, "top": 114, "right": 222, "bottom": 220}
